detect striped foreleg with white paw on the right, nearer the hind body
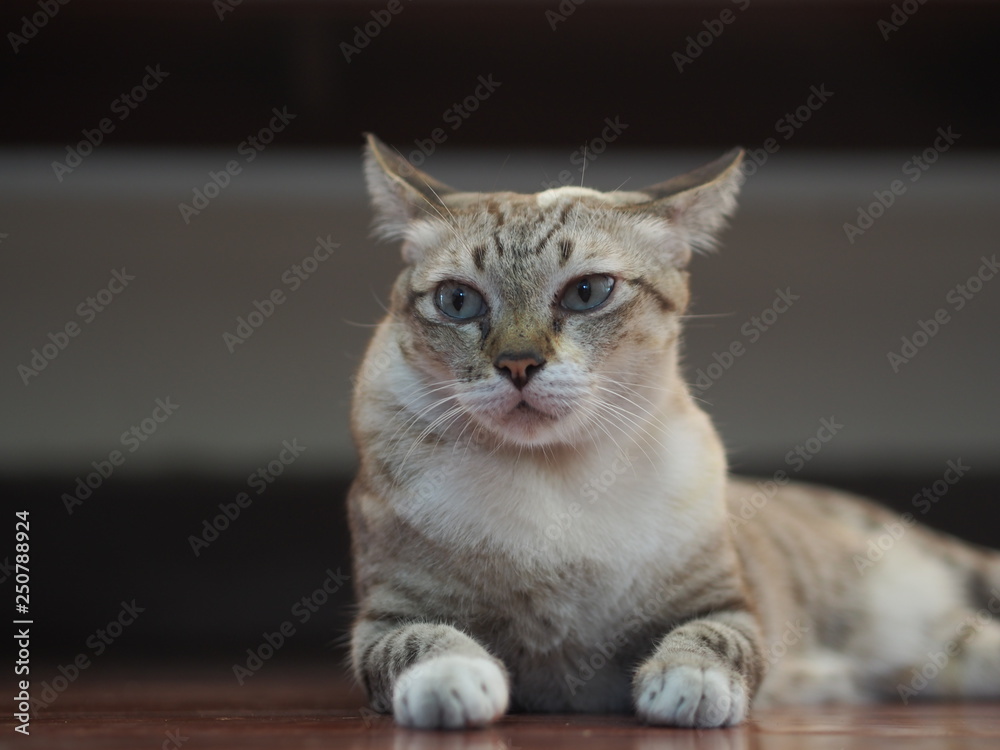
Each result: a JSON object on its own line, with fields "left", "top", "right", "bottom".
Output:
{"left": 632, "top": 611, "right": 763, "bottom": 729}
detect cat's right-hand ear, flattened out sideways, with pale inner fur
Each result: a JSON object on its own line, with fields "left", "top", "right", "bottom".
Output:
{"left": 626, "top": 148, "right": 744, "bottom": 256}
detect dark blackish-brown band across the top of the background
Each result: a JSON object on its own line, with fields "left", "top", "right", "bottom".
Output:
{"left": 0, "top": 0, "right": 1000, "bottom": 150}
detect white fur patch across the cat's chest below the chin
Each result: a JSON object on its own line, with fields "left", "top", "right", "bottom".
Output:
{"left": 398, "top": 464, "right": 689, "bottom": 568}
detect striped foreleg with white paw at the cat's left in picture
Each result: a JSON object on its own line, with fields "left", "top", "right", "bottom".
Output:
{"left": 352, "top": 620, "right": 510, "bottom": 729}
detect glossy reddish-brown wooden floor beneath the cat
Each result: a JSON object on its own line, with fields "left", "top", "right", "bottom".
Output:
{"left": 11, "top": 665, "right": 1000, "bottom": 750}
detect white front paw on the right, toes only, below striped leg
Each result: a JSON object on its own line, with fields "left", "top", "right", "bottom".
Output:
{"left": 635, "top": 665, "right": 748, "bottom": 729}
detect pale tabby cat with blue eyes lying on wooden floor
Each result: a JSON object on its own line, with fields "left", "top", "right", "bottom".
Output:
{"left": 348, "top": 136, "right": 1000, "bottom": 728}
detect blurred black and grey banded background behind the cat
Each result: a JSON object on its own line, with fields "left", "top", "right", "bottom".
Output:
{"left": 0, "top": 0, "right": 1000, "bottom": 679}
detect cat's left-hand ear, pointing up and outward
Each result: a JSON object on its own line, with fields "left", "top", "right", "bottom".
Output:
{"left": 365, "top": 133, "right": 455, "bottom": 238}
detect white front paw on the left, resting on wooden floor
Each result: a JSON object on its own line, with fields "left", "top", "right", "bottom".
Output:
{"left": 392, "top": 656, "right": 510, "bottom": 729}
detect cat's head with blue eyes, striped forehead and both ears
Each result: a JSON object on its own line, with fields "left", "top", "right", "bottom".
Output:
{"left": 365, "top": 136, "right": 743, "bottom": 448}
